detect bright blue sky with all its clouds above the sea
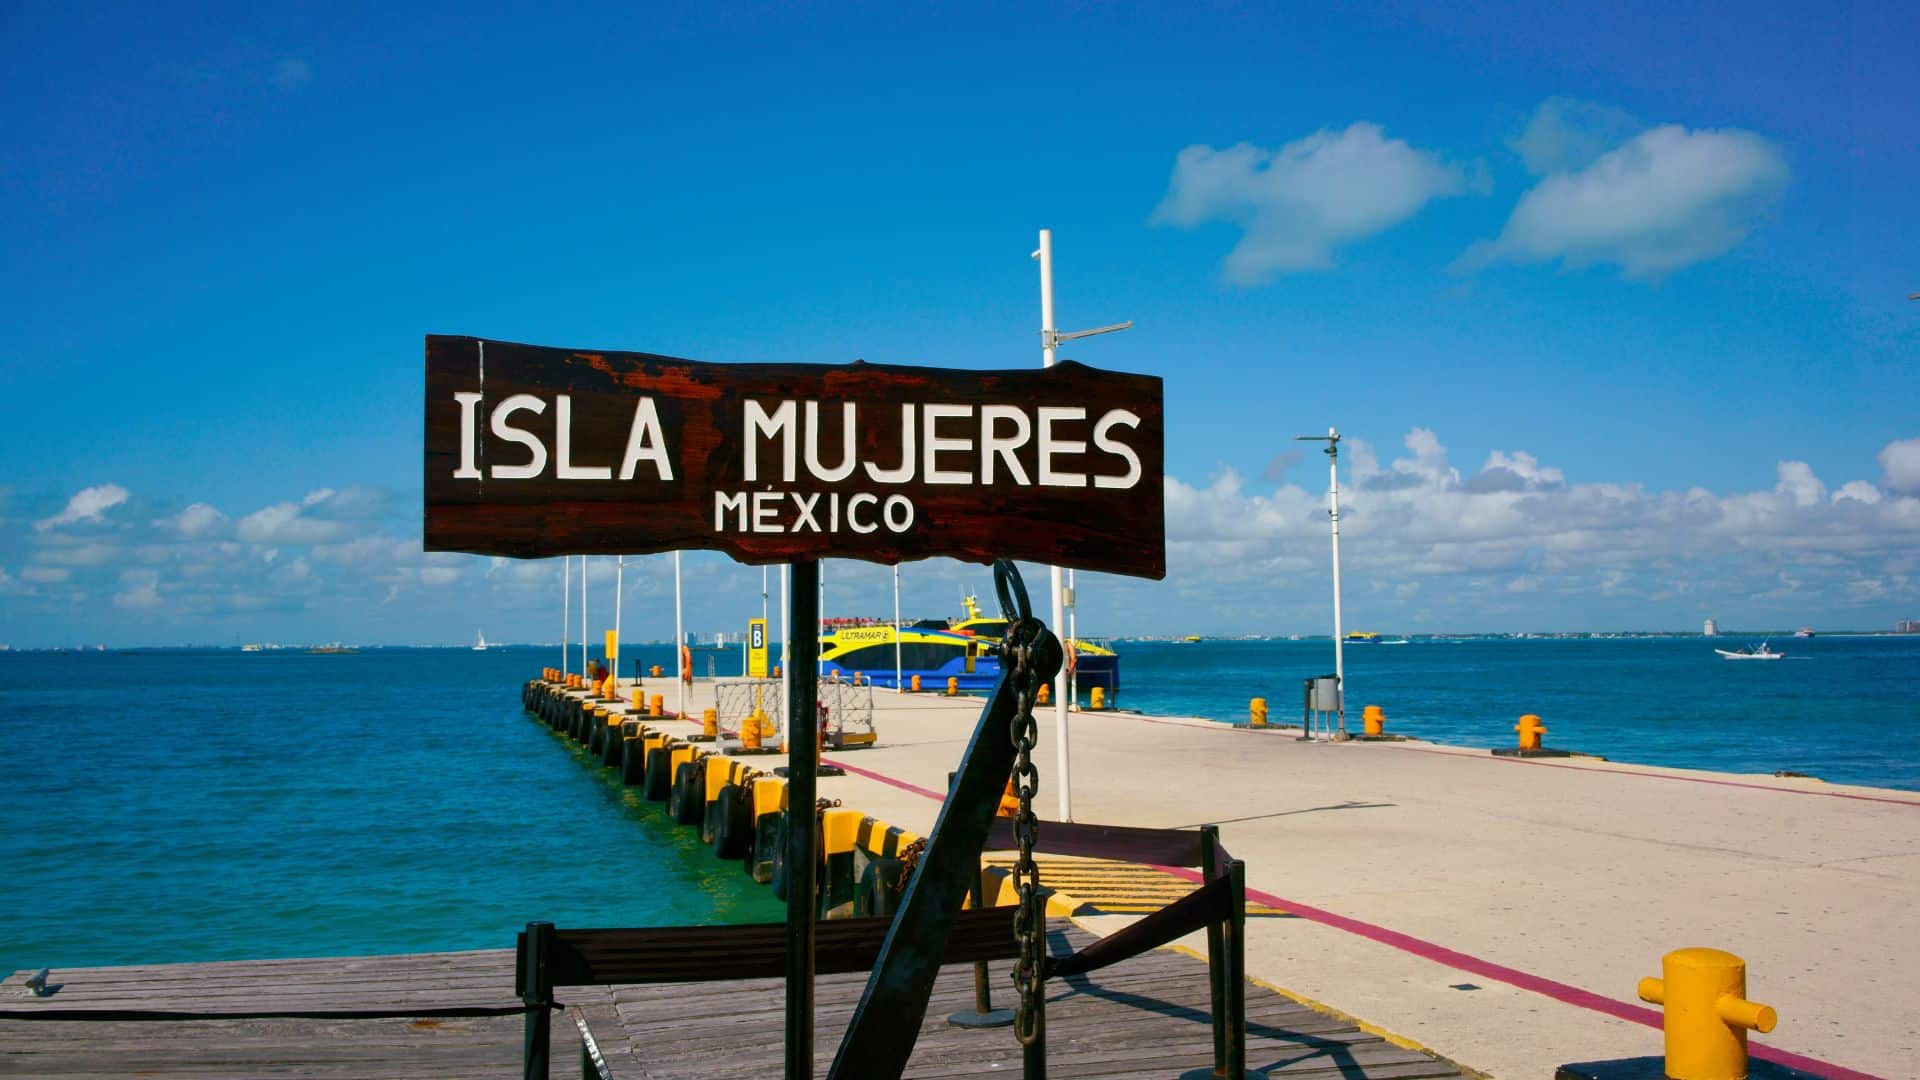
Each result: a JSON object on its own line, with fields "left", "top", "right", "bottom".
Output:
{"left": 0, "top": 2, "right": 1920, "bottom": 648}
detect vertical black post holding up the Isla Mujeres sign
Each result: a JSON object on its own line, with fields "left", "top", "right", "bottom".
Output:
{"left": 785, "top": 561, "right": 820, "bottom": 1080}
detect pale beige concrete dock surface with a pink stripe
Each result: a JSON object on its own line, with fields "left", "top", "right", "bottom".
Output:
{"left": 653, "top": 680, "right": 1920, "bottom": 1078}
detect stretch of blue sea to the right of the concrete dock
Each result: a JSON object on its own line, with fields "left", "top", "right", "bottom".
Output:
{"left": 1119, "top": 636, "right": 1920, "bottom": 790}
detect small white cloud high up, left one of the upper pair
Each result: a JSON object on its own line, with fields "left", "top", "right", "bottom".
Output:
{"left": 1152, "top": 123, "right": 1467, "bottom": 284}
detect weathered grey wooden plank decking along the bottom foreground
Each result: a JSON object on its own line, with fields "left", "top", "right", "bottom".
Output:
{"left": 0, "top": 919, "right": 1461, "bottom": 1080}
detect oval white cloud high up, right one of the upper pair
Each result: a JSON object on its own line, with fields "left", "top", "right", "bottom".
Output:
{"left": 1457, "top": 125, "right": 1789, "bottom": 277}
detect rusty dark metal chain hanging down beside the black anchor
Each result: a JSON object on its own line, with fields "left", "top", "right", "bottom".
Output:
{"left": 1004, "top": 619, "right": 1046, "bottom": 1045}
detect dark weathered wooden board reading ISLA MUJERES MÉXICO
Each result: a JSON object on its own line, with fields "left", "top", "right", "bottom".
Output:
{"left": 426, "top": 336, "right": 1165, "bottom": 578}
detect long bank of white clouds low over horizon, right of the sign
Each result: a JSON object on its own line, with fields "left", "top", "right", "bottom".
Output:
{"left": 1167, "top": 429, "right": 1920, "bottom": 626}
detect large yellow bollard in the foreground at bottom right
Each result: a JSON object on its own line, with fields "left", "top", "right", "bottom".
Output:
{"left": 1640, "top": 949, "right": 1780, "bottom": 1080}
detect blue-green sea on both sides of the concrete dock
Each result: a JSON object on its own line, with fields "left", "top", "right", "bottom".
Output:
{"left": 0, "top": 636, "right": 1920, "bottom": 972}
